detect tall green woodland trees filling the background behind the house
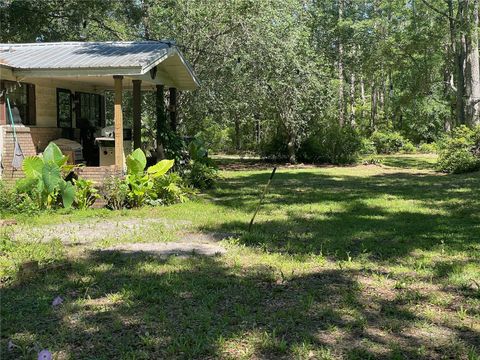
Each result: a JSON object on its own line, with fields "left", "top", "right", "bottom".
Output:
{"left": 0, "top": 0, "right": 480, "bottom": 158}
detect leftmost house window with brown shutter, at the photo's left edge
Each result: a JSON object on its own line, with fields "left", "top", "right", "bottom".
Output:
{"left": 0, "top": 80, "right": 36, "bottom": 125}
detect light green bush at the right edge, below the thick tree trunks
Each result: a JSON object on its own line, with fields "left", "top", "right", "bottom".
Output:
{"left": 438, "top": 125, "right": 480, "bottom": 174}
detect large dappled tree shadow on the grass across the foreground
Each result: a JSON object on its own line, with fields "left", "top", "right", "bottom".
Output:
{"left": 1, "top": 252, "right": 480, "bottom": 359}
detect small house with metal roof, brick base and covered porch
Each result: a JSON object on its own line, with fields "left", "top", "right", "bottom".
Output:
{"left": 0, "top": 41, "right": 199, "bottom": 182}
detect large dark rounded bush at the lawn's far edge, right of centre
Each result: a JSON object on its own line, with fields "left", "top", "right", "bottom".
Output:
{"left": 297, "top": 124, "right": 362, "bottom": 164}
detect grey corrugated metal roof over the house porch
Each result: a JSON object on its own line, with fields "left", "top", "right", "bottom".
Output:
{"left": 0, "top": 41, "right": 199, "bottom": 89}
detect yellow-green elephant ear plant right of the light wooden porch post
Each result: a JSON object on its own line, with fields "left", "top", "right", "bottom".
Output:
{"left": 125, "top": 149, "right": 174, "bottom": 207}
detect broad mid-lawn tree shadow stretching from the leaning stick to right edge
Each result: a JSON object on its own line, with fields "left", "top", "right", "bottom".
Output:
{"left": 207, "top": 171, "right": 480, "bottom": 261}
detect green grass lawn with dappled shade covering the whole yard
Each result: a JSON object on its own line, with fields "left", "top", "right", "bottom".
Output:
{"left": 0, "top": 156, "right": 480, "bottom": 359}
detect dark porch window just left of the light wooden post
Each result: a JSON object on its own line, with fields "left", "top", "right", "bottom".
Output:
{"left": 77, "top": 92, "right": 105, "bottom": 128}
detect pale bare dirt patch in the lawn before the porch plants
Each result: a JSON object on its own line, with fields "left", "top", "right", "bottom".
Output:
{"left": 13, "top": 218, "right": 233, "bottom": 258}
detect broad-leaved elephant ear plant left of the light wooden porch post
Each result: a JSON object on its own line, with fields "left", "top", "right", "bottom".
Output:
{"left": 16, "top": 143, "right": 75, "bottom": 209}
